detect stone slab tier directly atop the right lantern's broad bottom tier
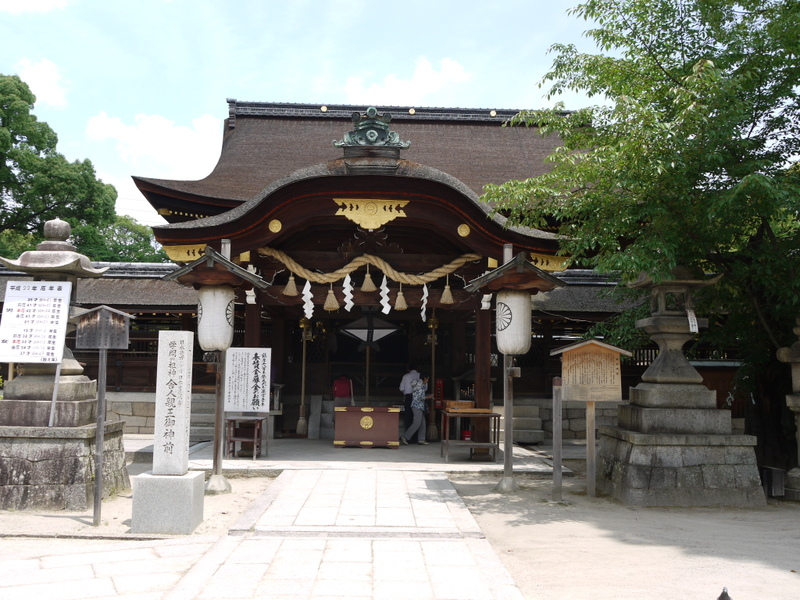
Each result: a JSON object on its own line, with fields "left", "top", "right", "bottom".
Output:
{"left": 618, "top": 404, "right": 731, "bottom": 435}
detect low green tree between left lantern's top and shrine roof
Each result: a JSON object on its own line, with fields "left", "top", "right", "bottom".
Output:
{"left": 72, "top": 215, "right": 169, "bottom": 262}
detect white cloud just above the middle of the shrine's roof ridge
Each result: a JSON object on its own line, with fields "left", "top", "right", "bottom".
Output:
{"left": 346, "top": 56, "right": 472, "bottom": 105}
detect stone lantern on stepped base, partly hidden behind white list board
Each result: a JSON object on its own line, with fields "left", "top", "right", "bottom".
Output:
{"left": 0, "top": 219, "right": 130, "bottom": 510}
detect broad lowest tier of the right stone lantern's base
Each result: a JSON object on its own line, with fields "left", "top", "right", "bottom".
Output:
{"left": 596, "top": 427, "right": 766, "bottom": 506}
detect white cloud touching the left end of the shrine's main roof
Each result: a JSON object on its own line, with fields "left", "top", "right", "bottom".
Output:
{"left": 86, "top": 112, "right": 222, "bottom": 179}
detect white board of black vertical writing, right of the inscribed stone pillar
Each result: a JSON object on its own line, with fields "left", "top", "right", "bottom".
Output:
{"left": 225, "top": 348, "right": 272, "bottom": 413}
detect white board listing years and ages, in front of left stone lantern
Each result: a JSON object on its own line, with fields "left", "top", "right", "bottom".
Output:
{"left": 0, "top": 281, "right": 72, "bottom": 364}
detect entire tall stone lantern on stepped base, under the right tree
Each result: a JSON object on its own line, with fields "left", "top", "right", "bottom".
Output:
{"left": 597, "top": 269, "right": 766, "bottom": 506}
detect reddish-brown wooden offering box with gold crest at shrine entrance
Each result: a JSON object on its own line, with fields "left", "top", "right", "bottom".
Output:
{"left": 333, "top": 406, "right": 400, "bottom": 449}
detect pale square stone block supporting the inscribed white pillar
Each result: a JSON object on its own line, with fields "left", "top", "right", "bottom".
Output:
{"left": 131, "top": 471, "right": 205, "bottom": 535}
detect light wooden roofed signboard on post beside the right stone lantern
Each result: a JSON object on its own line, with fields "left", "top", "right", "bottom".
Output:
{"left": 550, "top": 340, "right": 632, "bottom": 402}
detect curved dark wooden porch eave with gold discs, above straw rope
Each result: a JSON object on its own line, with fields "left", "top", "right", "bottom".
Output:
{"left": 153, "top": 159, "right": 558, "bottom": 258}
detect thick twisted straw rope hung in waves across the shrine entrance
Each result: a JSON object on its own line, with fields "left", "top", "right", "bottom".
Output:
{"left": 258, "top": 246, "right": 481, "bottom": 285}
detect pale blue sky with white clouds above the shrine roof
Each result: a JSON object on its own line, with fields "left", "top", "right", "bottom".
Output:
{"left": 0, "top": 0, "right": 594, "bottom": 224}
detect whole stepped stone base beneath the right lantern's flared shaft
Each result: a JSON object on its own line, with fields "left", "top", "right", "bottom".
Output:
{"left": 596, "top": 383, "right": 766, "bottom": 506}
